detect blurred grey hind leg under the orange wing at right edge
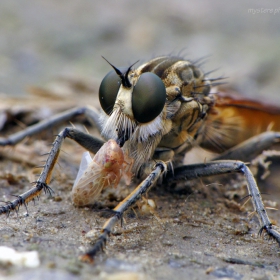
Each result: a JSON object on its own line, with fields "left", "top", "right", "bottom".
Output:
{"left": 215, "top": 131, "right": 280, "bottom": 161}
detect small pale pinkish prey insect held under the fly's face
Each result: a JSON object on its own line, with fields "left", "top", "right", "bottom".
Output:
{"left": 71, "top": 139, "right": 133, "bottom": 206}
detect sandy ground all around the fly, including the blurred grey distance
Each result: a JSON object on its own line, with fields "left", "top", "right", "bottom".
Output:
{"left": 0, "top": 0, "right": 280, "bottom": 279}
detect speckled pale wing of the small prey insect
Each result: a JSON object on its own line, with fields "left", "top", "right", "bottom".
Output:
{"left": 71, "top": 161, "right": 107, "bottom": 206}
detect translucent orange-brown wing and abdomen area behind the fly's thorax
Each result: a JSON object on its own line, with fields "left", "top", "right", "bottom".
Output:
{"left": 198, "top": 90, "right": 280, "bottom": 153}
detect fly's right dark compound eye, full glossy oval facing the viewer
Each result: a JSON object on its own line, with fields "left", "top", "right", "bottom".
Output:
{"left": 132, "top": 72, "right": 166, "bottom": 123}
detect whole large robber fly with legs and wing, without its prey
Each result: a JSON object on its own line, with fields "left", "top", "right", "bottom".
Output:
{"left": 0, "top": 56, "right": 280, "bottom": 260}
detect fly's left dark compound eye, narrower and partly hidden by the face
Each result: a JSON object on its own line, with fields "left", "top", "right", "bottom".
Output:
{"left": 99, "top": 67, "right": 127, "bottom": 115}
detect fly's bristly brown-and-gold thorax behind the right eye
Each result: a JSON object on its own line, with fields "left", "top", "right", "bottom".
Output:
{"left": 138, "top": 57, "right": 213, "bottom": 149}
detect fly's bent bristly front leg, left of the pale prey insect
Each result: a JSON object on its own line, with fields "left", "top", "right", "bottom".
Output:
{"left": 0, "top": 128, "right": 104, "bottom": 215}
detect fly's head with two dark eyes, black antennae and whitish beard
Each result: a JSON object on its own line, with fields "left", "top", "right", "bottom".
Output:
{"left": 99, "top": 58, "right": 166, "bottom": 150}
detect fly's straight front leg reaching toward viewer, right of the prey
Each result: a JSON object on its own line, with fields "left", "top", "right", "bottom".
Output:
{"left": 81, "top": 161, "right": 167, "bottom": 262}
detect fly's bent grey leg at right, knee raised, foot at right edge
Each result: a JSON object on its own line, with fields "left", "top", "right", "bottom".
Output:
{"left": 167, "top": 160, "right": 280, "bottom": 243}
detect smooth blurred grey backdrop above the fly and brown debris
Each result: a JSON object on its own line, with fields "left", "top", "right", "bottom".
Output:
{"left": 0, "top": 0, "right": 280, "bottom": 101}
